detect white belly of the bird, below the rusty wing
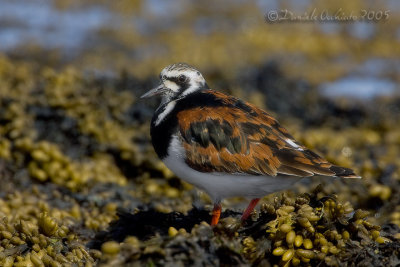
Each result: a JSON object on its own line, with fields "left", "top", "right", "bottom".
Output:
{"left": 163, "top": 137, "right": 301, "bottom": 202}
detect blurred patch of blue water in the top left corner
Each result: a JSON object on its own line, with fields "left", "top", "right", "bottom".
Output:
{"left": 0, "top": 0, "right": 115, "bottom": 51}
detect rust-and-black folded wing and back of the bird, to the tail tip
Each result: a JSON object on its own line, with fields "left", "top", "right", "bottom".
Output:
{"left": 177, "top": 90, "right": 359, "bottom": 178}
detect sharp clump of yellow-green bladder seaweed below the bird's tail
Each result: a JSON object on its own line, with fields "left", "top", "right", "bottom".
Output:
{"left": 243, "top": 192, "right": 390, "bottom": 266}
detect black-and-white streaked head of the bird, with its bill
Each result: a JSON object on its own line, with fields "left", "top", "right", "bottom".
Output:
{"left": 141, "top": 63, "right": 208, "bottom": 103}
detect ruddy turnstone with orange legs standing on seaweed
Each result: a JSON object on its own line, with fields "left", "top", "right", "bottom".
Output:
{"left": 142, "top": 63, "right": 360, "bottom": 225}
